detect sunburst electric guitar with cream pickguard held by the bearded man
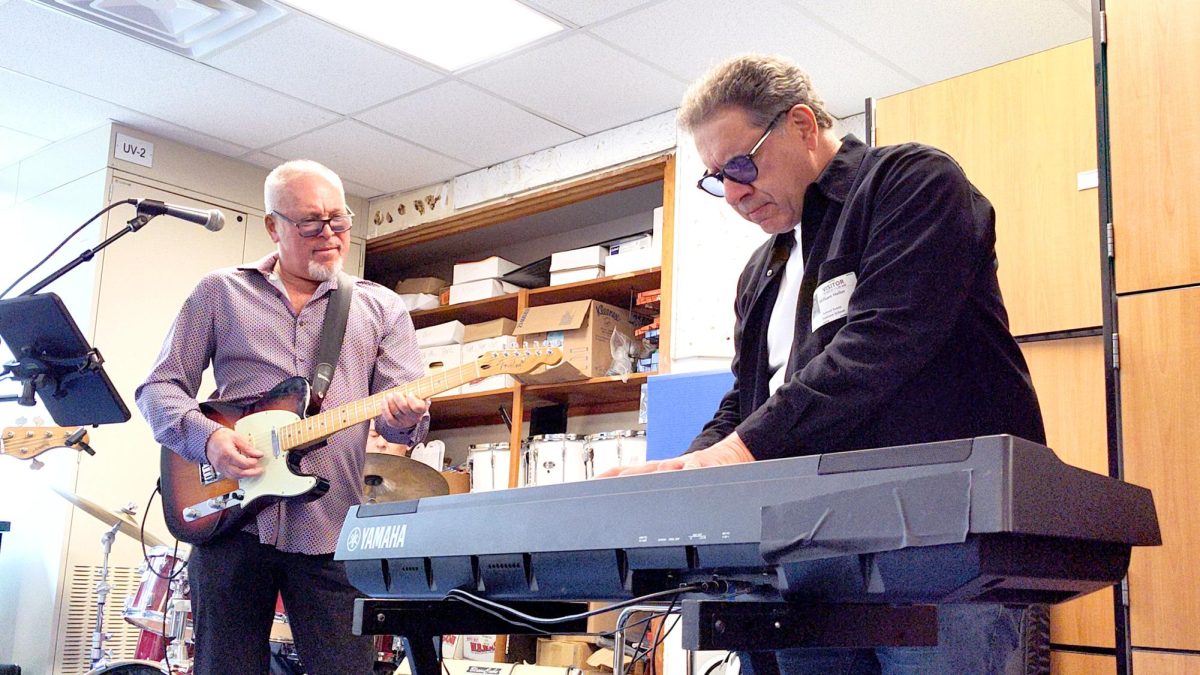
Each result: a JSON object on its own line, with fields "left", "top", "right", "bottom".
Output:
{"left": 161, "top": 347, "right": 563, "bottom": 544}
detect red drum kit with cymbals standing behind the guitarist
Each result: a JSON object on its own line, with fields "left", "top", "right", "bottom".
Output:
{"left": 46, "top": 453, "right": 449, "bottom": 675}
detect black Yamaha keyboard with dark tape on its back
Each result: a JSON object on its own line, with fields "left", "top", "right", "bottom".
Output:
{"left": 336, "top": 436, "right": 1162, "bottom": 604}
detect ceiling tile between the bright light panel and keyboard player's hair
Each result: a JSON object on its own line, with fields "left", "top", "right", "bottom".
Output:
{"left": 462, "top": 34, "right": 684, "bottom": 133}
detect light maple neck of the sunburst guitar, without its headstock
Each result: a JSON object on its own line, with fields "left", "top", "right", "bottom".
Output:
{"left": 278, "top": 362, "right": 482, "bottom": 450}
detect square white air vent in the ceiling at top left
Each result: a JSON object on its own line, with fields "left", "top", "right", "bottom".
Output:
{"left": 38, "top": 0, "right": 287, "bottom": 59}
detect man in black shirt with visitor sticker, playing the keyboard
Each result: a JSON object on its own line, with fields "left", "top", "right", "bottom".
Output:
{"left": 604, "top": 55, "right": 1046, "bottom": 675}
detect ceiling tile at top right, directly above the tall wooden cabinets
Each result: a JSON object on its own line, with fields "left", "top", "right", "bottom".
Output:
{"left": 804, "top": 0, "right": 1092, "bottom": 83}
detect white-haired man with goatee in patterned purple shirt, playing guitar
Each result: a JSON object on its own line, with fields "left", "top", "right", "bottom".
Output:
{"left": 137, "top": 160, "right": 428, "bottom": 674}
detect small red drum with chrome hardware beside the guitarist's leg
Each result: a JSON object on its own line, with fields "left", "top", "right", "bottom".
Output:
{"left": 122, "top": 546, "right": 192, "bottom": 640}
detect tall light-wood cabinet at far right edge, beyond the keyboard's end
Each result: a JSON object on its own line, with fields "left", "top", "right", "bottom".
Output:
{"left": 1104, "top": 0, "right": 1200, "bottom": 673}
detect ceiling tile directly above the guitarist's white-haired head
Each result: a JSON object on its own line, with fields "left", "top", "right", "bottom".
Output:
{"left": 268, "top": 120, "right": 472, "bottom": 193}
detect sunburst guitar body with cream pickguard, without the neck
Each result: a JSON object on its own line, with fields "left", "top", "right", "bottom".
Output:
{"left": 161, "top": 377, "right": 329, "bottom": 544}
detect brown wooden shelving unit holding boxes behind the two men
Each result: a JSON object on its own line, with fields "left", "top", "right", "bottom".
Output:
{"left": 367, "top": 155, "right": 674, "bottom": 486}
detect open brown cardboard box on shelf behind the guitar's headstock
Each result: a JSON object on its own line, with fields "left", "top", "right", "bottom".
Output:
{"left": 512, "top": 300, "right": 634, "bottom": 383}
